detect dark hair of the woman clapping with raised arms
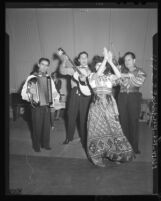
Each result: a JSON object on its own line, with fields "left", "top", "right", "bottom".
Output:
{"left": 91, "top": 55, "right": 114, "bottom": 75}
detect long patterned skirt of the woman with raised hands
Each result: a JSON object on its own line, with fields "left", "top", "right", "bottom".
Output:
{"left": 87, "top": 97, "right": 135, "bottom": 167}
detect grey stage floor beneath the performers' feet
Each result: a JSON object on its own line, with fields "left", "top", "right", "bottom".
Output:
{"left": 9, "top": 117, "right": 153, "bottom": 195}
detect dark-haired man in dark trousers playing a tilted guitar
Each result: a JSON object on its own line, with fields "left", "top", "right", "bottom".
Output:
{"left": 60, "top": 51, "right": 91, "bottom": 148}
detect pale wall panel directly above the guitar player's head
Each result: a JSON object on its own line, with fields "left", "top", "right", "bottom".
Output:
{"left": 74, "top": 9, "right": 110, "bottom": 60}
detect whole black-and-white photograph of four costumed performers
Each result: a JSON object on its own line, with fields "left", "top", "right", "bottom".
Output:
{"left": 5, "top": 2, "right": 158, "bottom": 196}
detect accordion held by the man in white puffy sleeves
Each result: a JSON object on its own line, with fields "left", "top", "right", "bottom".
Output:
{"left": 27, "top": 76, "right": 53, "bottom": 107}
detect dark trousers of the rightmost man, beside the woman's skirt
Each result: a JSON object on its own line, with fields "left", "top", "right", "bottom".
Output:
{"left": 118, "top": 92, "right": 142, "bottom": 152}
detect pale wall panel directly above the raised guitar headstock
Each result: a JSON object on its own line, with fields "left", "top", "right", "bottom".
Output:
{"left": 36, "top": 9, "right": 74, "bottom": 72}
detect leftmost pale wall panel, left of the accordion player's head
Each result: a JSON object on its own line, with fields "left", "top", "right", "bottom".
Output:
{"left": 7, "top": 9, "right": 41, "bottom": 89}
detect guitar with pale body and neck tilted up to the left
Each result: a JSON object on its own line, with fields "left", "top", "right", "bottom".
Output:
{"left": 57, "top": 48, "right": 91, "bottom": 96}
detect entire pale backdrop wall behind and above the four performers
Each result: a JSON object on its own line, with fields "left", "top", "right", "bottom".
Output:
{"left": 6, "top": 8, "right": 157, "bottom": 98}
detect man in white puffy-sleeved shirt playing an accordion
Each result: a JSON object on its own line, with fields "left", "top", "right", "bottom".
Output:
{"left": 21, "top": 58, "right": 60, "bottom": 152}
